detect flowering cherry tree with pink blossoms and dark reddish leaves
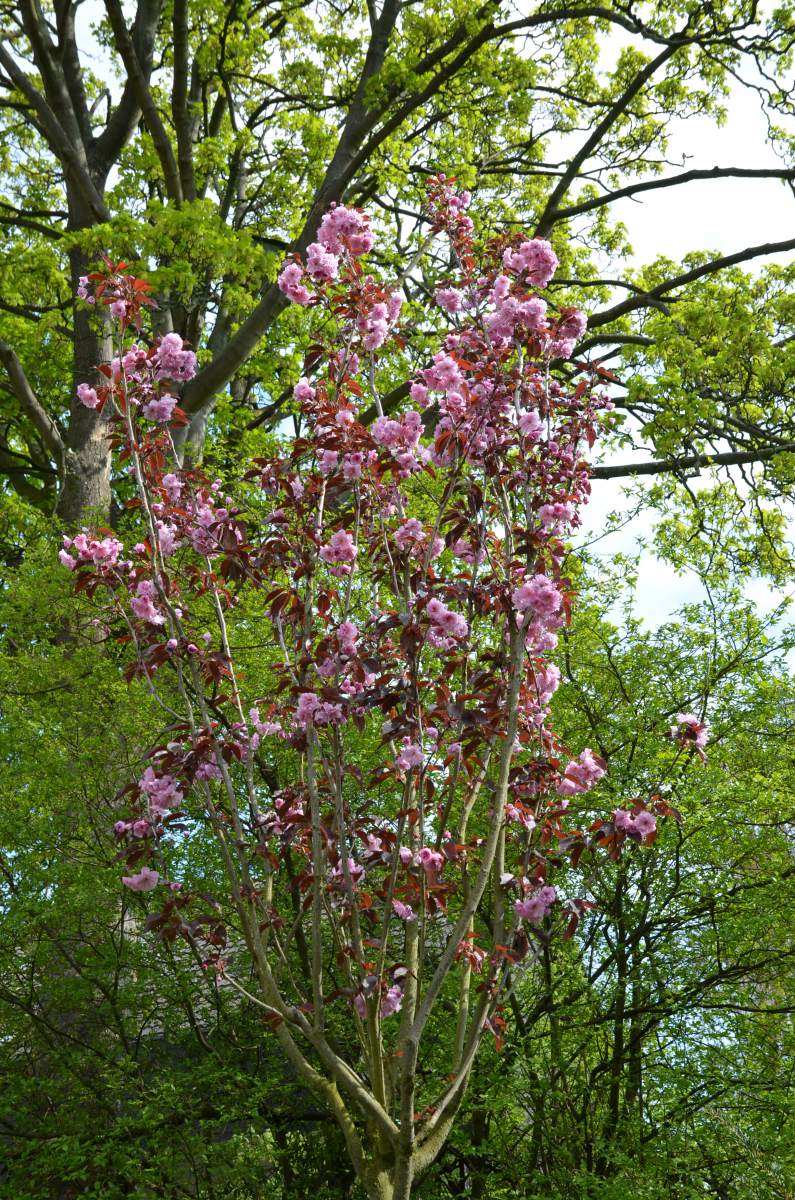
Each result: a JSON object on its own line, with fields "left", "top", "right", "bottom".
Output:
{"left": 60, "top": 176, "right": 682, "bottom": 1200}
